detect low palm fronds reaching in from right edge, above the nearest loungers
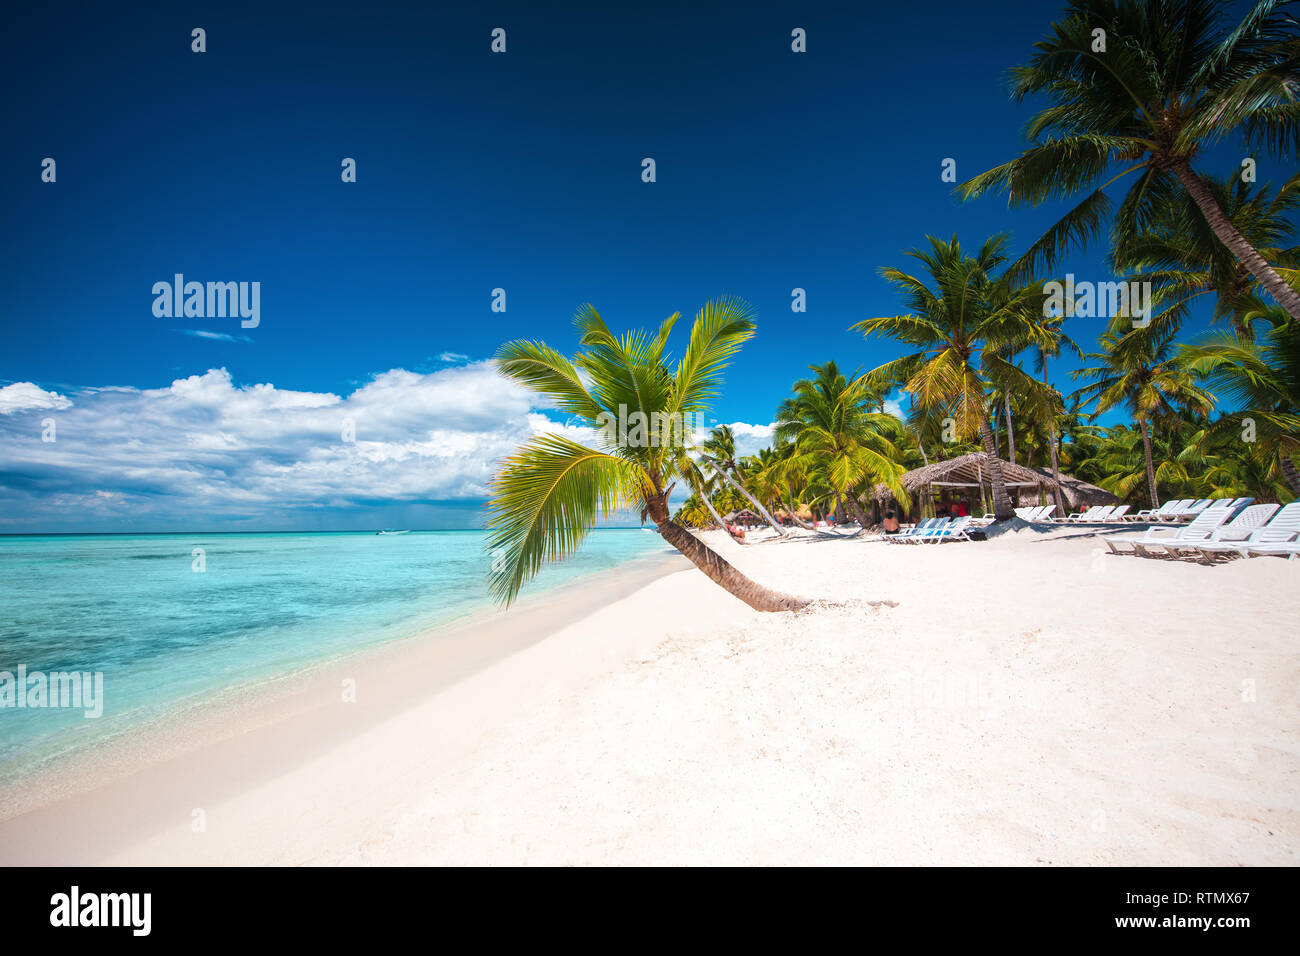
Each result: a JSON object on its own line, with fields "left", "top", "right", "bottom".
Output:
{"left": 1179, "top": 315, "right": 1300, "bottom": 494}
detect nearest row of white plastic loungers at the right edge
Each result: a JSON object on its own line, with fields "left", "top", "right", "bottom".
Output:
{"left": 1101, "top": 498, "right": 1300, "bottom": 562}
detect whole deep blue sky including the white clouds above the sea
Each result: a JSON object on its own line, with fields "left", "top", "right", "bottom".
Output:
{"left": 0, "top": 0, "right": 1283, "bottom": 531}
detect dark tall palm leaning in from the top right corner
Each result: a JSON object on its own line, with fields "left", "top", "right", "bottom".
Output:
{"left": 958, "top": 0, "right": 1300, "bottom": 319}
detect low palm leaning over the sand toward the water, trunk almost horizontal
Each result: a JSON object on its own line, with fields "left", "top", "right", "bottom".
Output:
{"left": 488, "top": 299, "right": 807, "bottom": 611}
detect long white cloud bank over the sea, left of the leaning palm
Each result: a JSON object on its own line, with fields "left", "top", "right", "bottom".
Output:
{"left": 0, "top": 362, "right": 543, "bottom": 527}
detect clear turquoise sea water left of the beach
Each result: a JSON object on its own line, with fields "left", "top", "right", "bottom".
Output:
{"left": 0, "top": 528, "right": 671, "bottom": 783}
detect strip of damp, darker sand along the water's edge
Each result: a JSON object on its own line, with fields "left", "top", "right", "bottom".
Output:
{"left": 0, "top": 553, "right": 689, "bottom": 865}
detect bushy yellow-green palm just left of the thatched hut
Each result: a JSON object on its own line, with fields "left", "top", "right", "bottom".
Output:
{"left": 774, "top": 362, "right": 904, "bottom": 528}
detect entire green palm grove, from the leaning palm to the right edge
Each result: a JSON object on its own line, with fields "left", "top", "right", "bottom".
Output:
{"left": 490, "top": 0, "right": 1300, "bottom": 610}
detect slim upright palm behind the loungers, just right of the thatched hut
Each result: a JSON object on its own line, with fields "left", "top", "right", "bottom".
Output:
{"left": 1073, "top": 325, "right": 1214, "bottom": 507}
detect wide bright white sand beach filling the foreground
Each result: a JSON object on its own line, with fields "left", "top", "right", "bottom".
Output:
{"left": 0, "top": 528, "right": 1300, "bottom": 865}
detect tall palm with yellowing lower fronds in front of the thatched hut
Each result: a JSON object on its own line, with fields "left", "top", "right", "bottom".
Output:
{"left": 853, "top": 235, "right": 1050, "bottom": 522}
